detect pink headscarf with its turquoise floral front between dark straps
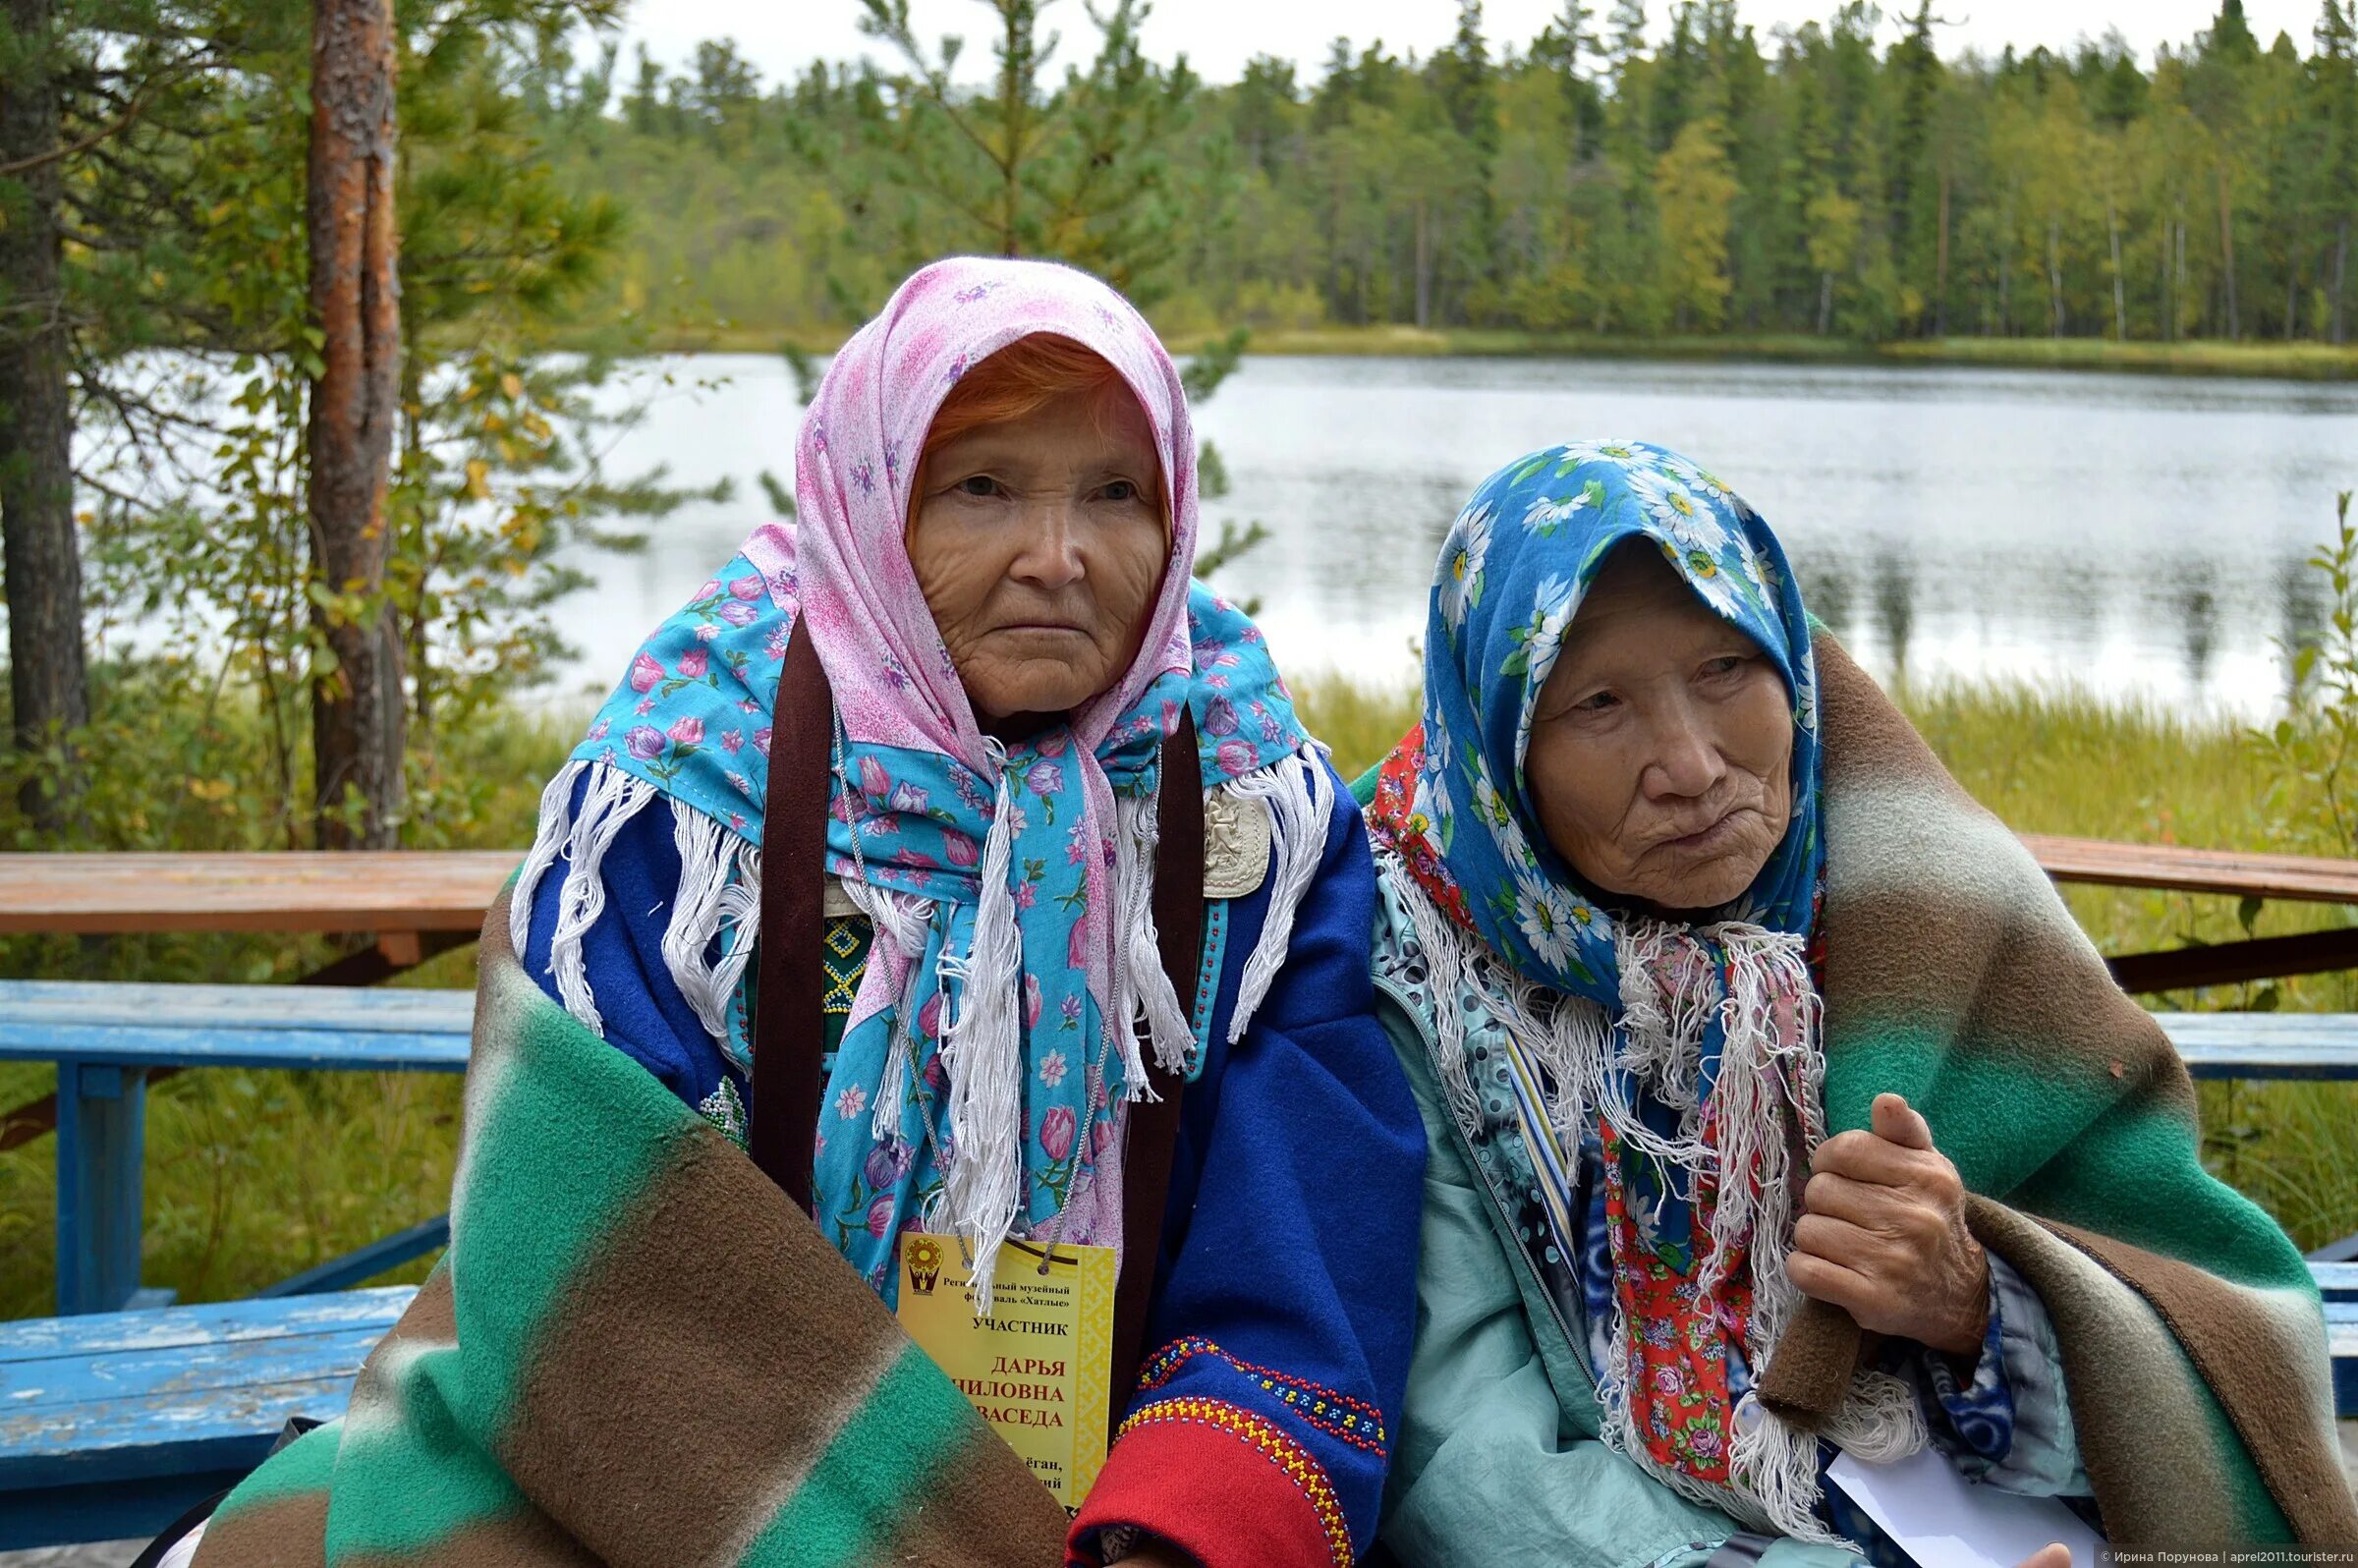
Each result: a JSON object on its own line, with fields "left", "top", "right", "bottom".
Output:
{"left": 788, "top": 257, "right": 1196, "bottom": 1278}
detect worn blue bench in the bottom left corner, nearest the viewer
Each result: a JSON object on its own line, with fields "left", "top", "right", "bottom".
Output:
{"left": 0, "top": 1285, "right": 418, "bottom": 1551}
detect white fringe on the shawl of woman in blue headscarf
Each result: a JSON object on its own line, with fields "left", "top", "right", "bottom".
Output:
{"left": 1377, "top": 847, "right": 1927, "bottom": 1544}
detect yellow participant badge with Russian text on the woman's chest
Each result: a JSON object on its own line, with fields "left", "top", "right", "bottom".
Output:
{"left": 901, "top": 1231, "right": 1115, "bottom": 1509}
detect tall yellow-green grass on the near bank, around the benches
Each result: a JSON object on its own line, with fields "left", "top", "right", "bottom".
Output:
{"left": 0, "top": 677, "right": 2358, "bottom": 1318}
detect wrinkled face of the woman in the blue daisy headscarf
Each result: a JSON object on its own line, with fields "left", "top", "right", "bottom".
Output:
{"left": 1523, "top": 544, "right": 1792, "bottom": 910}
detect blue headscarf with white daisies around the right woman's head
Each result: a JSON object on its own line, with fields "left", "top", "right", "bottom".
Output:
{"left": 1375, "top": 441, "right": 1823, "bottom": 985}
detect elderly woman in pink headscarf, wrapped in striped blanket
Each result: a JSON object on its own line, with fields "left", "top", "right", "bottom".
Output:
{"left": 171, "top": 259, "right": 1425, "bottom": 1568}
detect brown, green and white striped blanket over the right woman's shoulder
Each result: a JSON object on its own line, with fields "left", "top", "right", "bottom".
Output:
{"left": 1764, "top": 635, "right": 2358, "bottom": 1549}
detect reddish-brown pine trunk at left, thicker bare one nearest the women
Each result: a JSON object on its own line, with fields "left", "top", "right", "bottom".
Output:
{"left": 309, "top": 0, "right": 403, "bottom": 849}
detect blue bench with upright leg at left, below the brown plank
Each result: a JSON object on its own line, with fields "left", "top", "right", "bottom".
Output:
{"left": 0, "top": 980, "right": 474, "bottom": 1316}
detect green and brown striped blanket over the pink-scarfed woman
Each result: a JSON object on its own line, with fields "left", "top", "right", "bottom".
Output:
{"left": 196, "top": 896, "right": 1066, "bottom": 1568}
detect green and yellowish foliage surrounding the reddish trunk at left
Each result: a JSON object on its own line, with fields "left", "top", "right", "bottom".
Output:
{"left": 10, "top": 0, "right": 717, "bottom": 849}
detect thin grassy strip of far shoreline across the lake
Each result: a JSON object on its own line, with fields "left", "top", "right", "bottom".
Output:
{"left": 598, "top": 325, "right": 2358, "bottom": 382}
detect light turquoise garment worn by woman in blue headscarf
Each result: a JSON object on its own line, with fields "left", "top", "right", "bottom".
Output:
{"left": 1375, "top": 844, "right": 2089, "bottom": 1568}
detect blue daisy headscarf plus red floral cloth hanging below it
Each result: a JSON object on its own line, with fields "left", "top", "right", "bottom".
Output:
{"left": 1370, "top": 441, "right": 1823, "bottom": 1485}
